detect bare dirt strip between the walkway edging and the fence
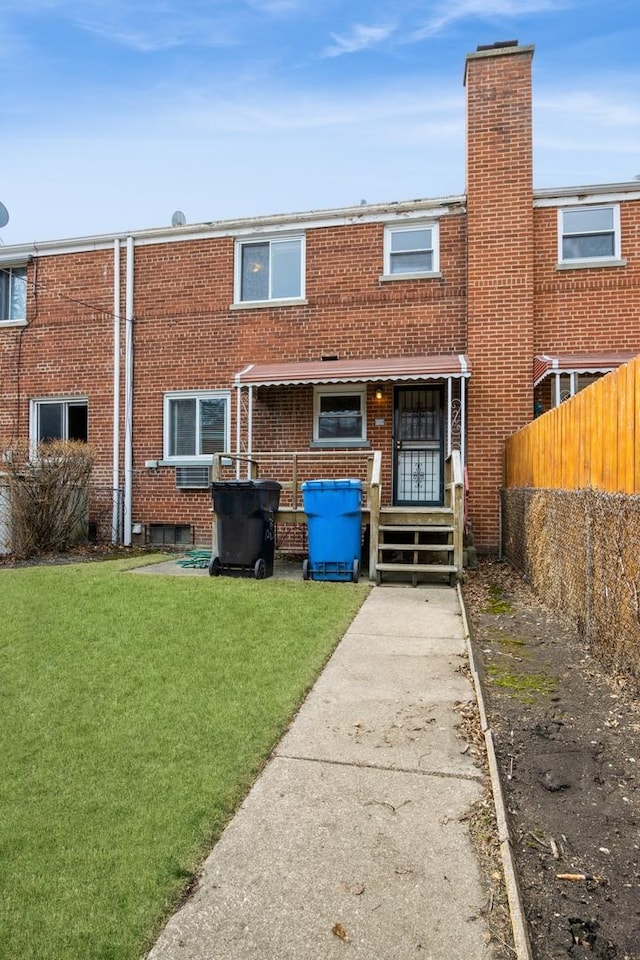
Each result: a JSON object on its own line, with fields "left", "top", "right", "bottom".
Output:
{"left": 463, "top": 561, "right": 640, "bottom": 960}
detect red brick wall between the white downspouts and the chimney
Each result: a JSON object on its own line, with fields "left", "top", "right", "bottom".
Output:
{"left": 133, "top": 215, "right": 465, "bottom": 542}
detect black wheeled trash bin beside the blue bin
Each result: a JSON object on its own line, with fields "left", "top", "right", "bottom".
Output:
{"left": 209, "top": 480, "right": 281, "bottom": 580}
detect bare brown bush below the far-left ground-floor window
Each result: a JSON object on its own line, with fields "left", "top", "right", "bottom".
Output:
{"left": 3, "top": 440, "right": 94, "bottom": 559}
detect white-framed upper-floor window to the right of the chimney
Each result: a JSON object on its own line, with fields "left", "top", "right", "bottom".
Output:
{"left": 558, "top": 204, "right": 620, "bottom": 263}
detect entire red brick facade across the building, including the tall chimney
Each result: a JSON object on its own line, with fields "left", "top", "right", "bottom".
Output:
{"left": 0, "top": 47, "right": 640, "bottom": 549}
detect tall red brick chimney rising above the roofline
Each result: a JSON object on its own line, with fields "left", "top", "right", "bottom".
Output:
{"left": 465, "top": 40, "right": 533, "bottom": 552}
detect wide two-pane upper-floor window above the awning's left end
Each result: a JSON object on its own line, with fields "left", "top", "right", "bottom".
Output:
{"left": 235, "top": 237, "right": 304, "bottom": 303}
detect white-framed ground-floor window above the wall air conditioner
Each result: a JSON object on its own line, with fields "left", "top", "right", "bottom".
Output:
{"left": 164, "top": 390, "right": 229, "bottom": 462}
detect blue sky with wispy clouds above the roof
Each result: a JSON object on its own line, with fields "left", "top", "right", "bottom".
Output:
{"left": 0, "top": 0, "right": 640, "bottom": 244}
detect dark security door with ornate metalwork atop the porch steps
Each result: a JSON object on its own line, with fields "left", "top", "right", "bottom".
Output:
{"left": 393, "top": 387, "right": 444, "bottom": 506}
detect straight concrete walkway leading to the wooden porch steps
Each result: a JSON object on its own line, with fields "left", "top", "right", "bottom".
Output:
{"left": 149, "top": 584, "right": 492, "bottom": 960}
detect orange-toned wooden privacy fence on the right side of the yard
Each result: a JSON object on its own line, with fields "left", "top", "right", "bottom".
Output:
{"left": 505, "top": 356, "right": 640, "bottom": 494}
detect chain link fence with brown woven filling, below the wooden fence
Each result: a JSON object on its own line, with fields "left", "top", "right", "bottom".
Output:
{"left": 502, "top": 488, "right": 640, "bottom": 690}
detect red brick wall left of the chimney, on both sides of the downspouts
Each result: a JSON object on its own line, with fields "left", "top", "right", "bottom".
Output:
{"left": 0, "top": 215, "right": 465, "bottom": 542}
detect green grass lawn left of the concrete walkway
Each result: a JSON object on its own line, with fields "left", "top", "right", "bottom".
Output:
{"left": 0, "top": 559, "right": 367, "bottom": 960}
